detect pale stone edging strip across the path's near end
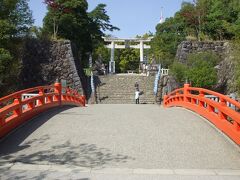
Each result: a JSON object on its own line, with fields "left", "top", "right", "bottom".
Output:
{"left": 0, "top": 162, "right": 240, "bottom": 176}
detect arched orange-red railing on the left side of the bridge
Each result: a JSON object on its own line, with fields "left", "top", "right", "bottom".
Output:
{"left": 0, "top": 83, "right": 86, "bottom": 138}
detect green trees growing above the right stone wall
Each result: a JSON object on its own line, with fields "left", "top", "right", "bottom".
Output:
{"left": 150, "top": 0, "right": 240, "bottom": 72}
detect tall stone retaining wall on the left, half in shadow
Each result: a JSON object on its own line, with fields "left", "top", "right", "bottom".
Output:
{"left": 21, "top": 39, "right": 84, "bottom": 93}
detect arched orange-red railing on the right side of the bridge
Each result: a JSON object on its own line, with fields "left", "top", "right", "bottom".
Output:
{"left": 164, "top": 84, "right": 240, "bottom": 145}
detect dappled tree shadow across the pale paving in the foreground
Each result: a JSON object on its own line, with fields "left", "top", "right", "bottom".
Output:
{"left": 2, "top": 141, "right": 134, "bottom": 168}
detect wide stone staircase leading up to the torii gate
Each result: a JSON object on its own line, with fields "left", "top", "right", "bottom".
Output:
{"left": 96, "top": 74, "right": 155, "bottom": 104}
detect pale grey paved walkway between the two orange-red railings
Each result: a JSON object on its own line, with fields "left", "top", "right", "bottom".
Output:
{"left": 0, "top": 105, "right": 240, "bottom": 180}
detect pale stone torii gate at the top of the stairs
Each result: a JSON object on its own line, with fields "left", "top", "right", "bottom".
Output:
{"left": 103, "top": 37, "right": 153, "bottom": 73}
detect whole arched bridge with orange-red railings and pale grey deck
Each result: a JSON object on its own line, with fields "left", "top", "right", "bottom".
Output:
{"left": 0, "top": 83, "right": 240, "bottom": 180}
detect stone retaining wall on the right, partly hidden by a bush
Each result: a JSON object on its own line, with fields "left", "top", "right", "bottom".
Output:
{"left": 176, "top": 41, "right": 237, "bottom": 94}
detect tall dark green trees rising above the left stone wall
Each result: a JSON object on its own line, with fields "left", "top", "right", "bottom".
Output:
{"left": 43, "top": 0, "right": 118, "bottom": 66}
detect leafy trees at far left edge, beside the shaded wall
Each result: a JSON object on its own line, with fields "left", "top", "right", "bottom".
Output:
{"left": 0, "top": 0, "right": 33, "bottom": 96}
